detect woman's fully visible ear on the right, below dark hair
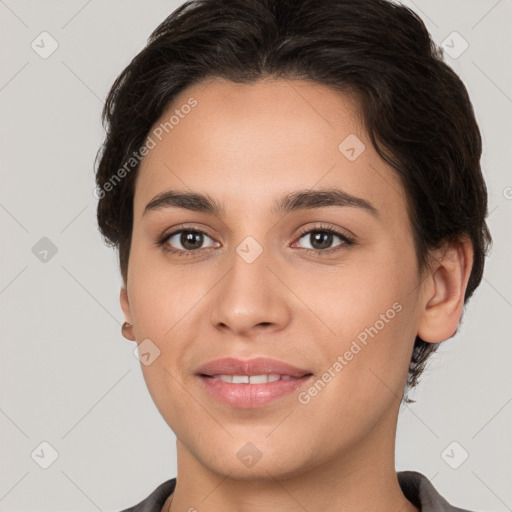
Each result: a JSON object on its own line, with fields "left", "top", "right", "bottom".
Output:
{"left": 418, "top": 237, "right": 473, "bottom": 343}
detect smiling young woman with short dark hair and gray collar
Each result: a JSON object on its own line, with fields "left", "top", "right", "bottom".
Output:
{"left": 97, "top": 0, "right": 491, "bottom": 512}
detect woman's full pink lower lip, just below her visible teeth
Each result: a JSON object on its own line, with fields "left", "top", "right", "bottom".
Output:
{"left": 199, "top": 375, "right": 313, "bottom": 409}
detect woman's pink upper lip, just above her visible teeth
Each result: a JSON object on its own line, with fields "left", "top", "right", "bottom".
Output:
{"left": 197, "top": 357, "right": 311, "bottom": 378}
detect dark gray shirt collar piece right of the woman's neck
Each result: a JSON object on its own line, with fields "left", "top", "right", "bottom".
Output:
{"left": 397, "top": 471, "right": 478, "bottom": 512}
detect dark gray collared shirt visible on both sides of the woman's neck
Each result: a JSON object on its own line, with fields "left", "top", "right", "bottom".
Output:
{"left": 121, "top": 471, "right": 471, "bottom": 512}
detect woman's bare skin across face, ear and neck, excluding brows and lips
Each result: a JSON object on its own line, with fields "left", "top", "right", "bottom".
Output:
{"left": 120, "top": 78, "right": 473, "bottom": 512}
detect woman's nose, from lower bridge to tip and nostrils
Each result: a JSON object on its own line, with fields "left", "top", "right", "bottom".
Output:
{"left": 211, "top": 242, "right": 292, "bottom": 337}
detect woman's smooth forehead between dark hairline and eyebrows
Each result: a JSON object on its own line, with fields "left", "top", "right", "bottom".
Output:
{"left": 135, "top": 78, "right": 403, "bottom": 215}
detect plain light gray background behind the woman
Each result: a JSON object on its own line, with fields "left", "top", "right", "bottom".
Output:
{"left": 0, "top": 0, "right": 512, "bottom": 512}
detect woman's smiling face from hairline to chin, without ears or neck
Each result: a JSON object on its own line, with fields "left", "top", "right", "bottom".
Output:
{"left": 121, "top": 79, "right": 421, "bottom": 479}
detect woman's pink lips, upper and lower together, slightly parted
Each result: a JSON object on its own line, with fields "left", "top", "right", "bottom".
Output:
{"left": 197, "top": 358, "right": 313, "bottom": 409}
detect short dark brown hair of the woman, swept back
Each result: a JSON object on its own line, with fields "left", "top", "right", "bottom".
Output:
{"left": 96, "top": 0, "right": 491, "bottom": 402}
